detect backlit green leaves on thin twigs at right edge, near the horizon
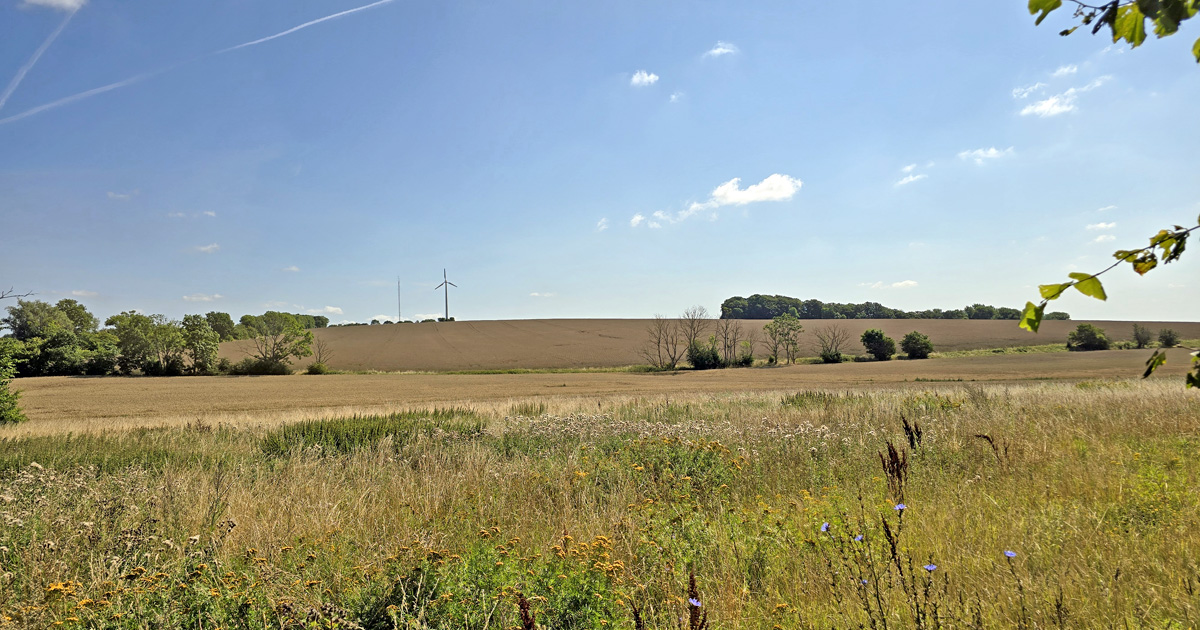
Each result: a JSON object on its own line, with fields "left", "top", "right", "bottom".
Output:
{"left": 1019, "top": 218, "right": 1200, "bottom": 388}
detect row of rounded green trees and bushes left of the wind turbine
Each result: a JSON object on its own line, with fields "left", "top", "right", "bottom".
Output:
{"left": 0, "top": 299, "right": 319, "bottom": 377}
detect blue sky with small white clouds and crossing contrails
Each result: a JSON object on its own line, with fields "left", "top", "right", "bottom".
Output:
{"left": 0, "top": 0, "right": 1200, "bottom": 323}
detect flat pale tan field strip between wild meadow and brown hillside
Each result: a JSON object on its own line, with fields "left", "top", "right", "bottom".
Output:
{"left": 11, "top": 345, "right": 1190, "bottom": 438}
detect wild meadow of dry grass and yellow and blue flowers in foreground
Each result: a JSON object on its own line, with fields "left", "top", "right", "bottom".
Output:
{"left": 0, "top": 382, "right": 1200, "bottom": 629}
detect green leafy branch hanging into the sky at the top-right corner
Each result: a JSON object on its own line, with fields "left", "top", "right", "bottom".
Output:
{"left": 1030, "top": 0, "right": 1200, "bottom": 64}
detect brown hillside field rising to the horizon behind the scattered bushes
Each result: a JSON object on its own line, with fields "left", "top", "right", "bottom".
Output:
{"left": 221, "top": 319, "right": 1200, "bottom": 372}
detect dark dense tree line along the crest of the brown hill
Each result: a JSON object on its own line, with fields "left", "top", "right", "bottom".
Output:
{"left": 721, "top": 293, "right": 1070, "bottom": 320}
